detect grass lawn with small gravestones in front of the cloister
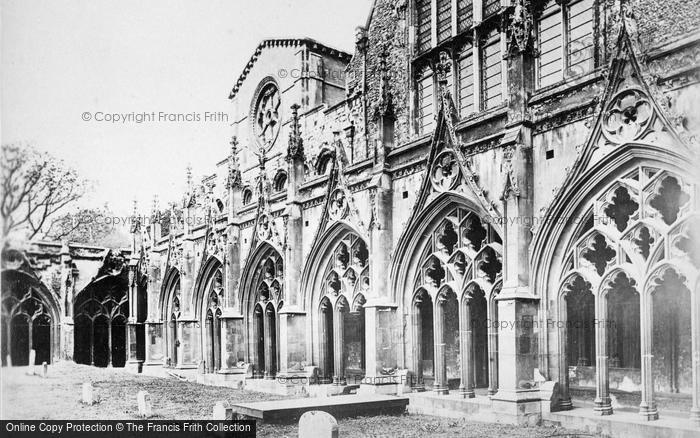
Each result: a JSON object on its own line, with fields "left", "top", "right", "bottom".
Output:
{"left": 0, "top": 362, "right": 592, "bottom": 438}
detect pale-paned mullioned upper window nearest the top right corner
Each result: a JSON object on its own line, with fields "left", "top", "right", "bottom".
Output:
{"left": 537, "top": 0, "right": 594, "bottom": 87}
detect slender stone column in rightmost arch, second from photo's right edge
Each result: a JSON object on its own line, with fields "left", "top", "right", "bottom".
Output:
{"left": 639, "top": 294, "right": 659, "bottom": 421}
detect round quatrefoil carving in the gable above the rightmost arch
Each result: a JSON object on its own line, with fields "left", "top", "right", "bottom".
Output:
{"left": 603, "top": 88, "right": 654, "bottom": 144}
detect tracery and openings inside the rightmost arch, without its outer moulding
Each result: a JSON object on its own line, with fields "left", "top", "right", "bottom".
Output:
{"left": 560, "top": 165, "right": 700, "bottom": 418}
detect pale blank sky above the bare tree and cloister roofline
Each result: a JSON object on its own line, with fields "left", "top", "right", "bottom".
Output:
{"left": 0, "top": 0, "right": 371, "bottom": 219}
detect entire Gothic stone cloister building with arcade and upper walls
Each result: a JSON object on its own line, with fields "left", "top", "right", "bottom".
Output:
{"left": 3, "top": 0, "right": 700, "bottom": 427}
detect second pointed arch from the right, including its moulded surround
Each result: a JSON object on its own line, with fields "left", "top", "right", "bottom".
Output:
{"left": 391, "top": 192, "right": 502, "bottom": 397}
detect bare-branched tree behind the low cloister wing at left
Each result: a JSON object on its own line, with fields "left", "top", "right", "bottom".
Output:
{"left": 0, "top": 144, "right": 87, "bottom": 240}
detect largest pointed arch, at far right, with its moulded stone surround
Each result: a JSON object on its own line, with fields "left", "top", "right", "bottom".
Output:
{"left": 530, "top": 151, "right": 698, "bottom": 419}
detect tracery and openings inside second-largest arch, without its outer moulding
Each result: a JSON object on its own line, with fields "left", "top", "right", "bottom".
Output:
{"left": 412, "top": 208, "right": 502, "bottom": 397}
